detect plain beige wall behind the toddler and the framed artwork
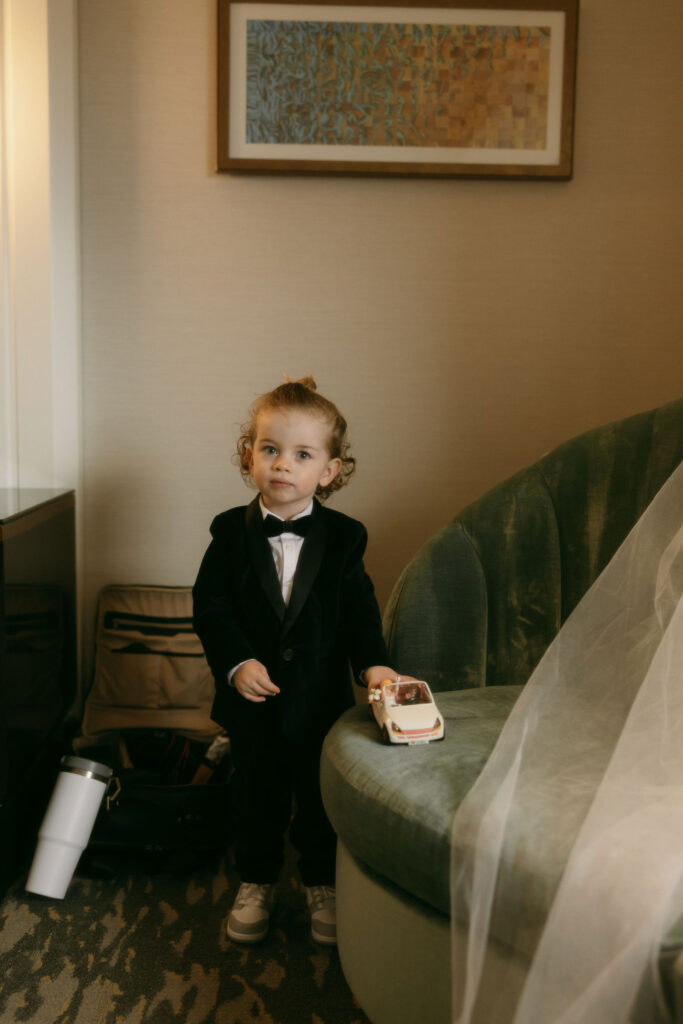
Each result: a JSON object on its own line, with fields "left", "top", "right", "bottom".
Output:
{"left": 80, "top": 0, "right": 683, "bottom": 663}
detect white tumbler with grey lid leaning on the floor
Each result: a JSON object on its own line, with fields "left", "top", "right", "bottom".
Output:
{"left": 26, "top": 757, "right": 112, "bottom": 899}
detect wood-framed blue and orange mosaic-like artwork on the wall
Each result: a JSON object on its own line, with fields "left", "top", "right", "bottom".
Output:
{"left": 217, "top": 0, "right": 579, "bottom": 180}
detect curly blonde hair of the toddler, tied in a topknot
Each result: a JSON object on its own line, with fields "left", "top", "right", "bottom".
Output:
{"left": 236, "top": 377, "right": 355, "bottom": 501}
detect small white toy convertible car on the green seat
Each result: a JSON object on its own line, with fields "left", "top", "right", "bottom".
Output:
{"left": 368, "top": 679, "right": 443, "bottom": 745}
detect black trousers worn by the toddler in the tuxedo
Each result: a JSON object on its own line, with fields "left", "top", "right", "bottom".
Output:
{"left": 230, "top": 697, "right": 337, "bottom": 886}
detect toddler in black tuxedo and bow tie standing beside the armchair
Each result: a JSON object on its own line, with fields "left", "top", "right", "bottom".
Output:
{"left": 194, "top": 378, "right": 403, "bottom": 944}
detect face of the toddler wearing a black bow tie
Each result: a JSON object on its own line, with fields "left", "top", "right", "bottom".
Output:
{"left": 249, "top": 409, "right": 341, "bottom": 519}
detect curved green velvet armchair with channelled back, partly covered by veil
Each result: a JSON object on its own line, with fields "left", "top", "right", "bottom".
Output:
{"left": 322, "top": 400, "right": 683, "bottom": 1024}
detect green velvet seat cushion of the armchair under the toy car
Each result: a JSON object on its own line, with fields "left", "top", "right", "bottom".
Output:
{"left": 321, "top": 686, "right": 521, "bottom": 914}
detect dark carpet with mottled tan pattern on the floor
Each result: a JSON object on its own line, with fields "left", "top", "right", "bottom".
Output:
{"left": 0, "top": 852, "right": 369, "bottom": 1024}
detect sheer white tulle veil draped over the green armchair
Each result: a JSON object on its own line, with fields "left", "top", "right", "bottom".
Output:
{"left": 452, "top": 464, "right": 683, "bottom": 1024}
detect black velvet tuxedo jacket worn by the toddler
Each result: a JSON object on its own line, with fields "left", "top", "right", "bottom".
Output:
{"left": 193, "top": 498, "right": 387, "bottom": 740}
